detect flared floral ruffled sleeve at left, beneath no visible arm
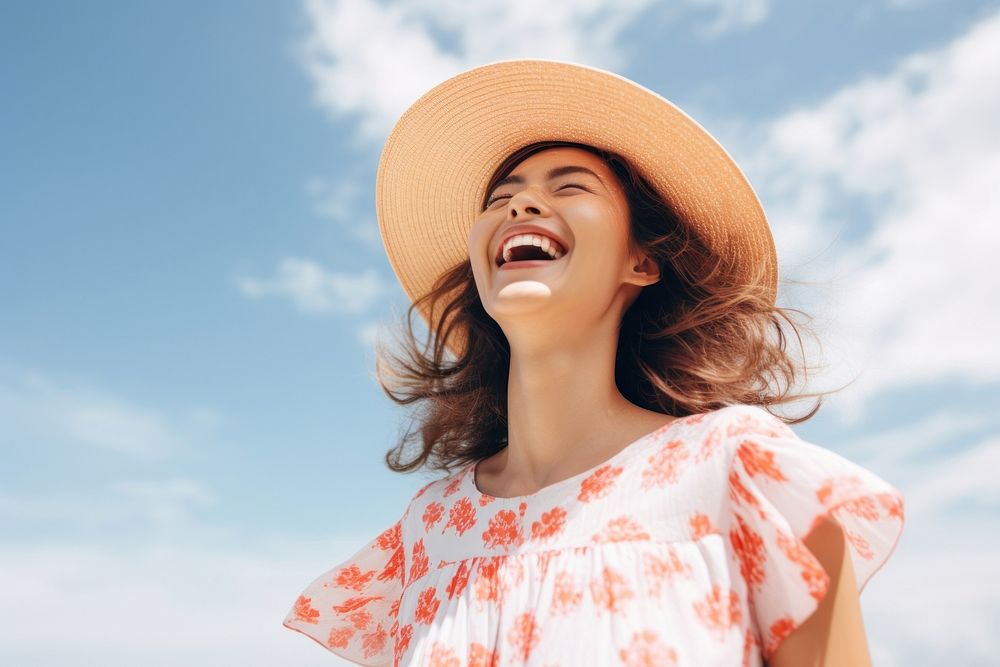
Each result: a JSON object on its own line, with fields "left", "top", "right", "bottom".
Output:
{"left": 283, "top": 519, "right": 406, "bottom": 665}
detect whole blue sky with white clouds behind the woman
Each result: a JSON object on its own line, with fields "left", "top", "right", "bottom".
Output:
{"left": 0, "top": 0, "right": 1000, "bottom": 665}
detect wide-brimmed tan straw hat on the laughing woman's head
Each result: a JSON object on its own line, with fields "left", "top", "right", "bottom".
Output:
{"left": 375, "top": 59, "right": 778, "bottom": 354}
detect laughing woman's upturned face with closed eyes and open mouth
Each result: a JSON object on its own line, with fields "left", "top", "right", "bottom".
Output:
{"left": 469, "top": 146, "right": 659, "bottom": 338}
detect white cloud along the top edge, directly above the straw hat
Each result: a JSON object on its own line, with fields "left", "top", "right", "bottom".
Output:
{"left": 292, "top": 0, "right": 768, "bottom": 140}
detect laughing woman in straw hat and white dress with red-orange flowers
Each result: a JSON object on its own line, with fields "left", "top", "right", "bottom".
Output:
{"left": 285, "top": 60, "right": 903, "bottom": 667}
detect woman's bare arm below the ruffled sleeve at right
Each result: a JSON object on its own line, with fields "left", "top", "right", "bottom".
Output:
{"left": 767, "top": 519, "right": 871, "bottom": 667}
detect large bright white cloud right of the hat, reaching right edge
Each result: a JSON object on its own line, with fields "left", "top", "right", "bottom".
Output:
{"left": 737, "top": 7, "right": 1000, "bottom": 419}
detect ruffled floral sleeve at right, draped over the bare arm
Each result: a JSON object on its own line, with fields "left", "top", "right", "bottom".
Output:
{"left": 726, "top": 405, "right": 903, "bottom": 660}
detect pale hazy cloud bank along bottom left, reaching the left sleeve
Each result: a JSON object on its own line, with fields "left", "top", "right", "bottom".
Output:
{"left": 0, "top": 538, "right": 368, "bottom": 667}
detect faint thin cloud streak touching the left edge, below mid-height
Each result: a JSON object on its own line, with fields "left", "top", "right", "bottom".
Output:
{"left": 0, "top": 372, "right": 203, "bottom": 457}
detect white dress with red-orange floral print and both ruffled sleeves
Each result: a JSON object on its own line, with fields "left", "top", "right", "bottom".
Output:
{"left": 284, "top": 404, "right": 903, "bottom": 667}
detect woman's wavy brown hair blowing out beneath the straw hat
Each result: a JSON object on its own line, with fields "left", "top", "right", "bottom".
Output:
{"left": 375, "top": 141, "right": 839, "bottom": 472}
